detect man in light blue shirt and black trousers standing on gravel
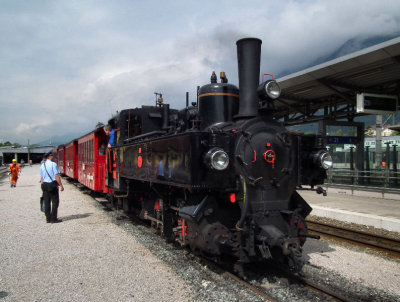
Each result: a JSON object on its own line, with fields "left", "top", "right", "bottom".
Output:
{"left": 40, "top": 152, "right": 64, "bottom": 223}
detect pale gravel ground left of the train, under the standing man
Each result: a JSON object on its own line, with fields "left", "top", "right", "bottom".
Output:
{"left": 0, "top": 165, "right": 194, "bottom": 302}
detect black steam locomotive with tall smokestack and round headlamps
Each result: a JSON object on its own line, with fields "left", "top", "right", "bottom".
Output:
{"left": 106, "top": 38, "right": 332, "bottom": 272}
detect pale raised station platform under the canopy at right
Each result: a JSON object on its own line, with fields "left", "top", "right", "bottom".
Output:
{"left": 299, "top": 188, "right": 400, "bottom": 233}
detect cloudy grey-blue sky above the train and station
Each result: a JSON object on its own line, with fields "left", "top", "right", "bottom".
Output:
{"left": 0, "top": 0, "right": 400, "bottom": 145}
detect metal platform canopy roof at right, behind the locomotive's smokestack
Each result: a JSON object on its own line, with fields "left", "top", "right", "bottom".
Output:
{"left": 275, "top": 37, "right": 400, "bottom": 125}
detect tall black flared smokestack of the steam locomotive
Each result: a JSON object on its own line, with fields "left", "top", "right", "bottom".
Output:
{"left": 235, "top": 38, "right": 262, "bottom": 119}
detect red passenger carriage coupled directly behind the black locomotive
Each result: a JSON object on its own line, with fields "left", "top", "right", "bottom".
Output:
{"left": 78, "top": 128, "right": 108, "bottom": 193}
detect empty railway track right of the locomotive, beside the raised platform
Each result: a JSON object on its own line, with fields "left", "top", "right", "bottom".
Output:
{"left": 307, "top": 221, "right": 400, "bottom": 258}
